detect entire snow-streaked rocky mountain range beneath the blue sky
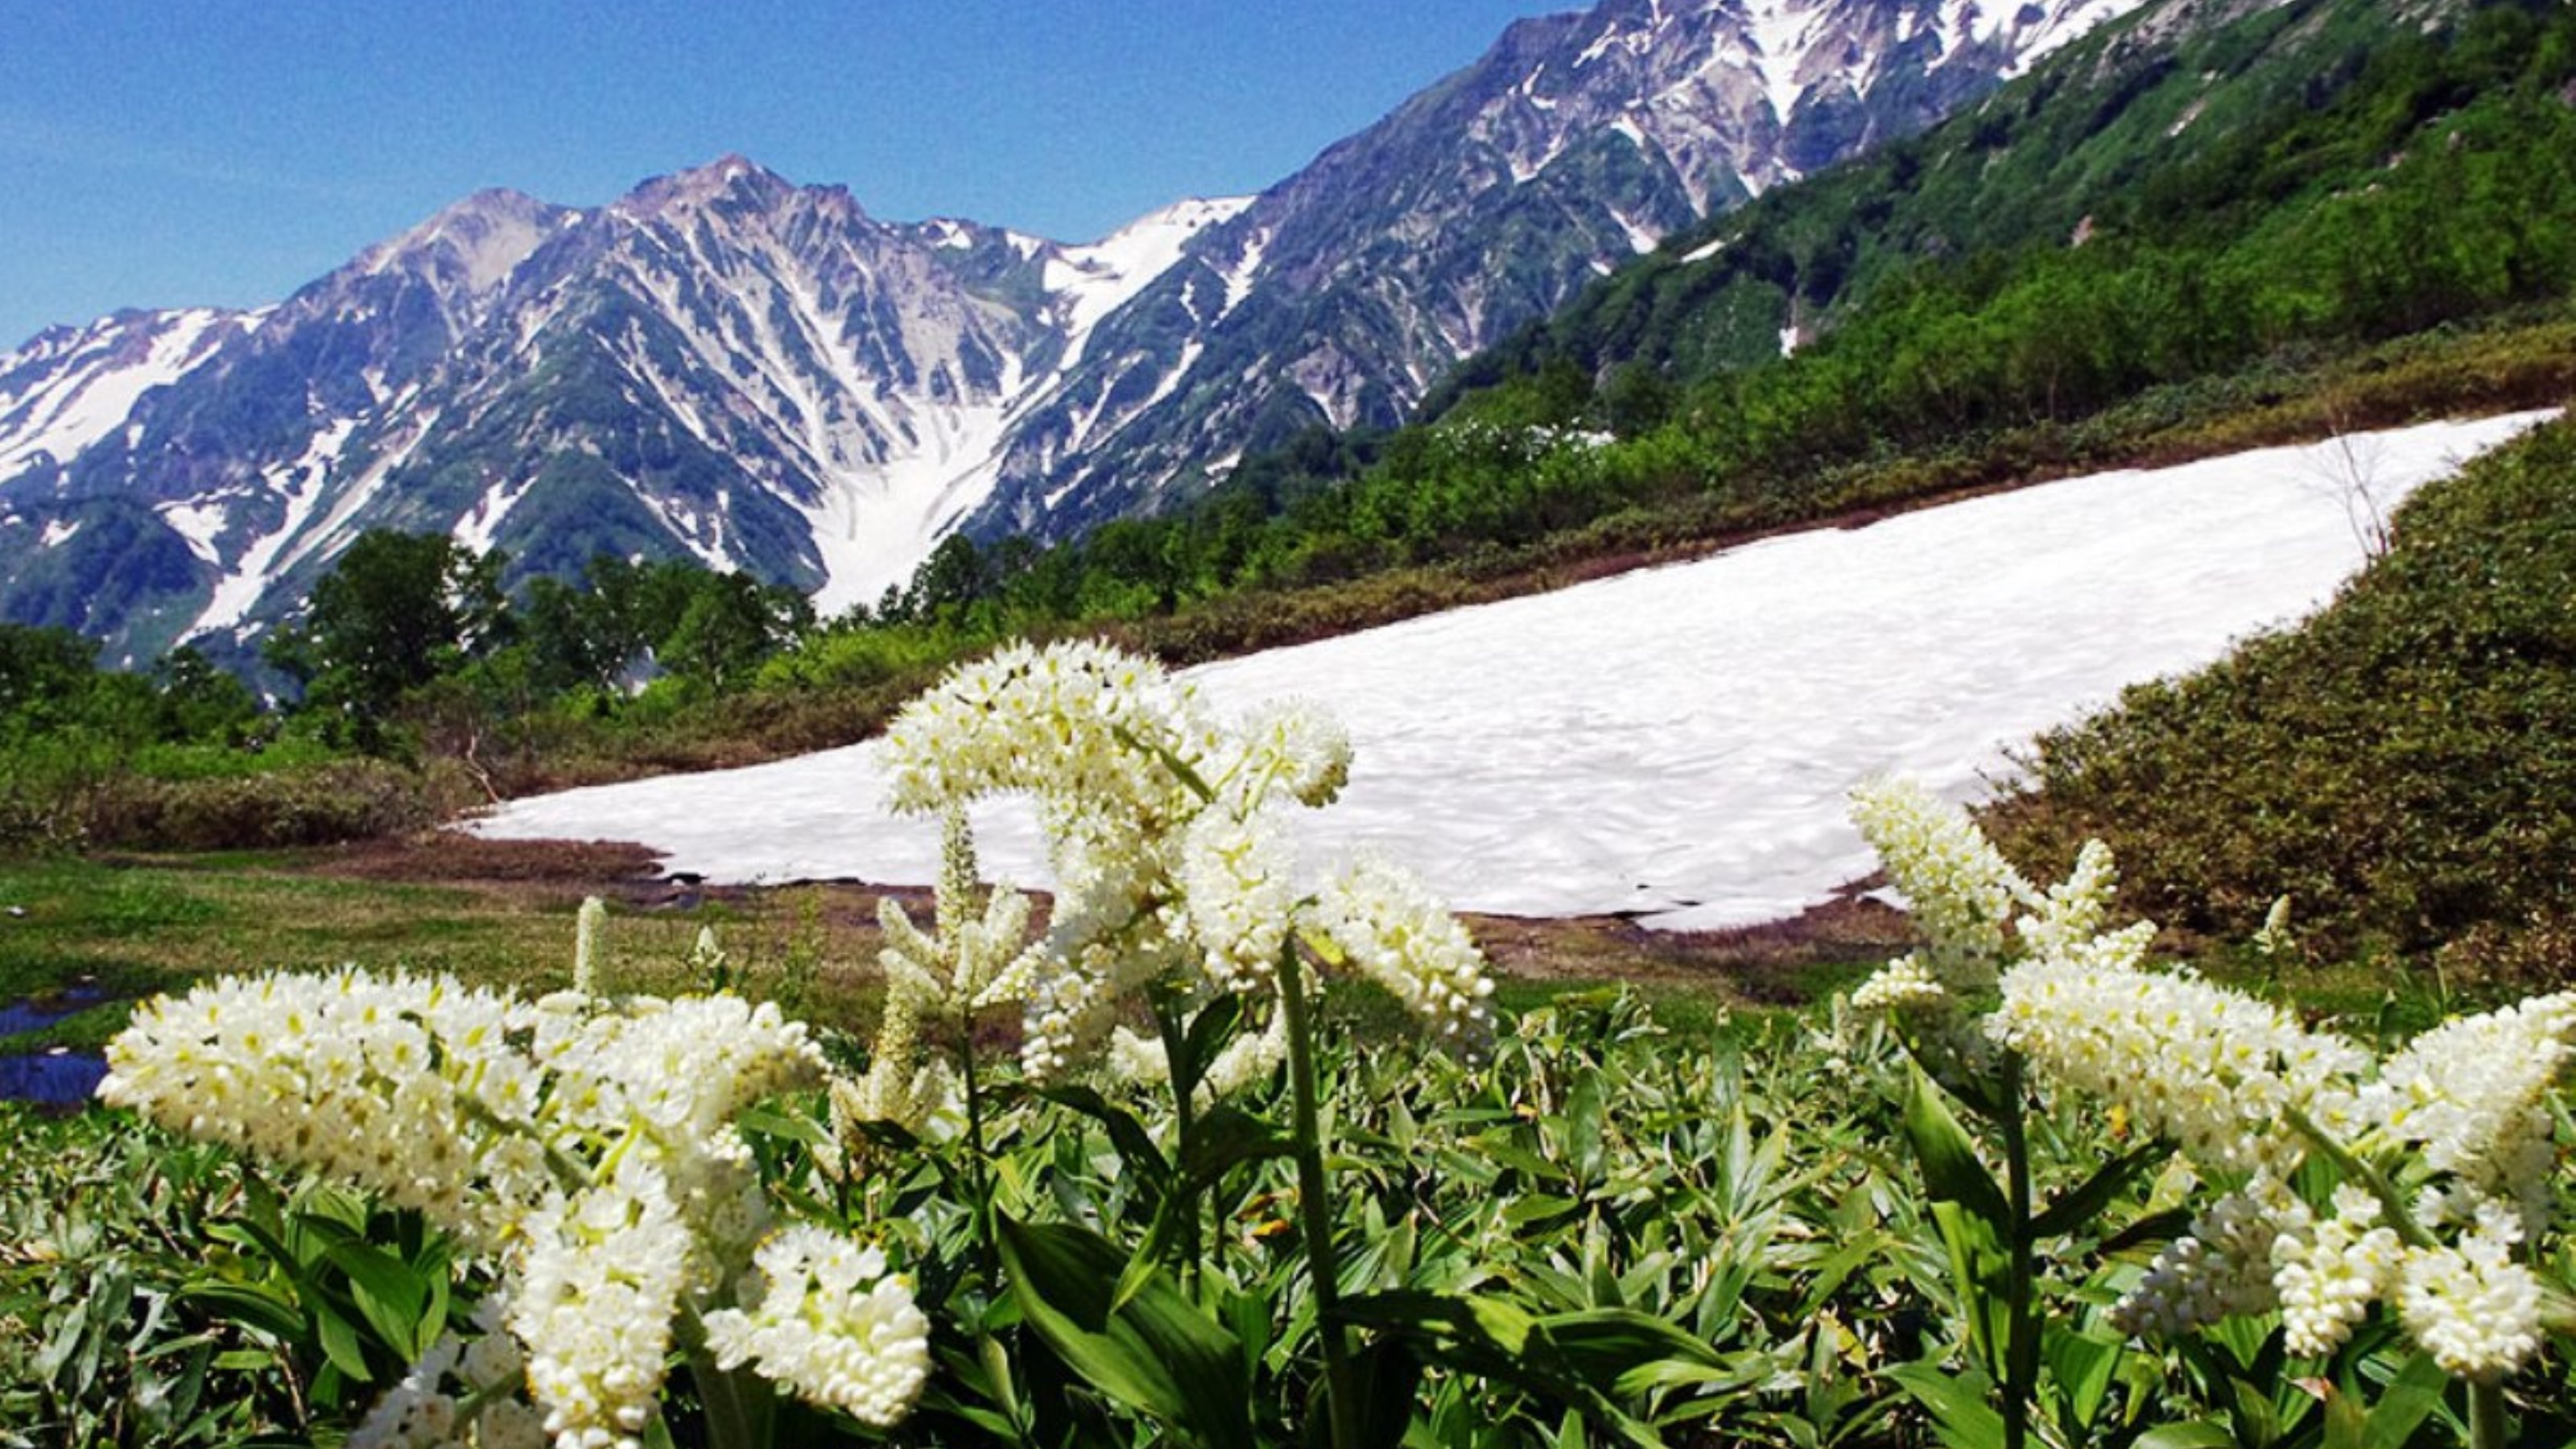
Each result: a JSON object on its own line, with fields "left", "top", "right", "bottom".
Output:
{"left": 0, "top": 0, "right": 2140, "bottom": 660}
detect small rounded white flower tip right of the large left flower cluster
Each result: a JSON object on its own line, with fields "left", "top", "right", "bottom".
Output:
{"left": 706, "top": 1224, "right": 930, "bottom": 1428}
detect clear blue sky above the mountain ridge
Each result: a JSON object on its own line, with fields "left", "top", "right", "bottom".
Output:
{"left": 0, "top": 0, "right": 1587, "bottom": 351}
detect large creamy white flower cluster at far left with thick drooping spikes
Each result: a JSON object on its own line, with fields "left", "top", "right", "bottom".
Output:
{"left": 101, "top": 969, "right": 937, "bottom": 1449}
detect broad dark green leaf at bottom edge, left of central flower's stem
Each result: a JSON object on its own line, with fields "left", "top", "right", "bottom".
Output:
{"left": 1000, "top": 1217, "right": 1252, "bottom": 1449}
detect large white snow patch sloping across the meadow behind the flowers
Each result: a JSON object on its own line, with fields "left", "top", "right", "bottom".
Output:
{"left": 474, "top": 412, "right": 2550, "bottom": 928}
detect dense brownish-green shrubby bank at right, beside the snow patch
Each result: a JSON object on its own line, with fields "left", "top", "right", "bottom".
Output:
{"left": 1994, "top": 410, "right": 2576, "bottom": 969}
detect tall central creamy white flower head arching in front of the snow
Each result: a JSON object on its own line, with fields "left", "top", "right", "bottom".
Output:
{"left": 886, "top": 645, "right": 1492, "bottom": 1080}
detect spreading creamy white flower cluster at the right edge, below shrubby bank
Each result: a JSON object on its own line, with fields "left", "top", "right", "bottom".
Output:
{"left": 1855, "top": 784, "right": 2576, "bottom": 1380}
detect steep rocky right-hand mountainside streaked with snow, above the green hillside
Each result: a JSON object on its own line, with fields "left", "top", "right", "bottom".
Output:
{"left": 976, "top": 0, "right": 2138, "bottom": 536}
